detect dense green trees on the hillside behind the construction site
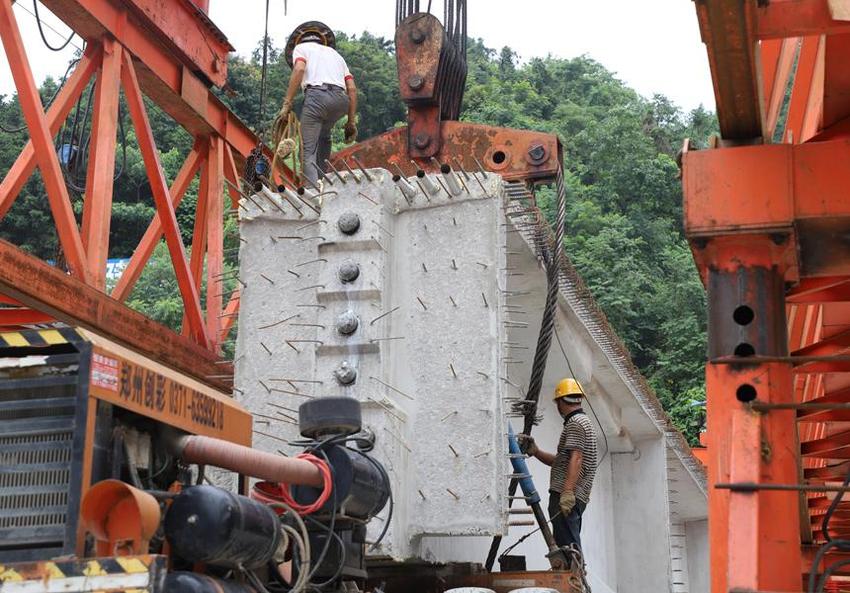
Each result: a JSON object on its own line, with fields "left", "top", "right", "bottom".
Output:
{"left": 0, "top": 33, "right": 716, "bottom": 441}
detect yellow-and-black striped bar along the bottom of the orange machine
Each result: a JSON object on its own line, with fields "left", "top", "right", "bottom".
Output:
{"left": 0, "top": 555, "right": 166, "bottom": 593}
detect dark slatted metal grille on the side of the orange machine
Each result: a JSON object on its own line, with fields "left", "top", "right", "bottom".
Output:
{"left": 0, "top": 354, "right": 85, "bottom": 561}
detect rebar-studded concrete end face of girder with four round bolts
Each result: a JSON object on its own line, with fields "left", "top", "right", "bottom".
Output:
{"left": 235, "top": 169, "right": 510, "bottom": 559}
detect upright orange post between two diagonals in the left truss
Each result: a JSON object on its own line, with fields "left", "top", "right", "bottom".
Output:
{"left": 83, "top": 39, "right": 122, "bottom": 290}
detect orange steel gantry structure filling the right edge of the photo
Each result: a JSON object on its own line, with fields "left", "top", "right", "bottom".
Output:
{"left": 683, "top": 0, "right": 850, "bottom": 593}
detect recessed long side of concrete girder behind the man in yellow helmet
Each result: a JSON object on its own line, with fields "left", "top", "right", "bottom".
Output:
{"left": 410, "top": 186, "right": 709, "bottom": 593}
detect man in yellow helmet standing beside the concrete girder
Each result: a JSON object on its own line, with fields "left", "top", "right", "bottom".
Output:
{"left": 522, "top": 378, "right": 597, "bottom": 550}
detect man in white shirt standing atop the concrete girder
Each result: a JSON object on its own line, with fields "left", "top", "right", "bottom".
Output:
{"left": 274, "top": 21, "right": 357, "bottom": 183}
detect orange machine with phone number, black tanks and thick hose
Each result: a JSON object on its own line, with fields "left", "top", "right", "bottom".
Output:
{"left": 0, "top": 329, "right": 390, "bottom": 591}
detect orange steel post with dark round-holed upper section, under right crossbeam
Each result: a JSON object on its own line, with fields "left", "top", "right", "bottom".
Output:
{"left": 692, "top": 234, "right": 800, "bottom": 593}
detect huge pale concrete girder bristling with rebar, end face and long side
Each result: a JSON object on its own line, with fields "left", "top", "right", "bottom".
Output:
{"left": 236, "top": 165, "right": 708, "bottom": 593}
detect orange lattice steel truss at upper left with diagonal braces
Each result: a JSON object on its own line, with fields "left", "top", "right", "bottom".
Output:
{"left": 0, "top": 0, "right": 288, "bottom": 386}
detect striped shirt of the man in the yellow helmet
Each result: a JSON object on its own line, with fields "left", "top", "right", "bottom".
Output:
{"left": 549, "top": 410, "right": 597, "bottom": 504}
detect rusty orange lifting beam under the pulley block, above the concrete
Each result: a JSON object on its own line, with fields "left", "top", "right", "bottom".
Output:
{"left": 332, "top": 121, "right": 562, "bottom": 181}
